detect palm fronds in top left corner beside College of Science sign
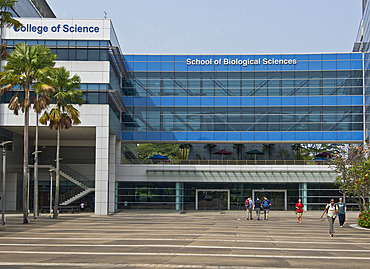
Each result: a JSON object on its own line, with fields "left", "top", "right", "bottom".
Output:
{"left": 0, "top": 0, "right": 22, "bottom": 59}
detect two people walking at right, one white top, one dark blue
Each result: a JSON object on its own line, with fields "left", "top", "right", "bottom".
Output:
{"left": 321, "top": 198, "right": 347, "bottom": 237}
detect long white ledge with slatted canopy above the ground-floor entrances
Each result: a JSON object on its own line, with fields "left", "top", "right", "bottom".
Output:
{"left": 116, "top": 164, "right": 336, "bottom": 183}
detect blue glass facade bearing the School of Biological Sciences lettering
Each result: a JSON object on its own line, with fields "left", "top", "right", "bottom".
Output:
{"left": 121, "top": 53, "right": 364, "bottom": 143}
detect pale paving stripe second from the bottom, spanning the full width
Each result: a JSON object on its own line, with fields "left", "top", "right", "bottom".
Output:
{"left": 0, "top": 250, "right": 370, "bottom": 260}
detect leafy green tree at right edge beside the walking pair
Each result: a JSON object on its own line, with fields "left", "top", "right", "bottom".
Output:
{"left": 330, "top": 146, "right": 370, "bottom": 213}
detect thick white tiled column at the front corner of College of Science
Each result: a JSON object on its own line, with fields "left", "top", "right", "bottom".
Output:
{"left": 95, "top": 124, "right": 109, "bottom": 215}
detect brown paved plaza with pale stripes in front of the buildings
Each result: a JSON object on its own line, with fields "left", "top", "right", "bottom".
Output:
{"left": 0, "top": 211, "right": 370, "bottom": 268}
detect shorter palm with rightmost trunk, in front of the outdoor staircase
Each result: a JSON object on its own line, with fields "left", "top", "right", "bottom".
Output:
{"left": 40, "top": 67, "right": 84, "bottom": 219}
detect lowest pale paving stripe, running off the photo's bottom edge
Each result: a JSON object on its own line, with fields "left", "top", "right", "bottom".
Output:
{"left": 0, "top": 262, "right": 307, "bottom": 269}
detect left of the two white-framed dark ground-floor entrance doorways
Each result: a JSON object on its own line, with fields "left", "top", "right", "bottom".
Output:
{"left": 195, "top": 189, "right": 230, "bottom": 210}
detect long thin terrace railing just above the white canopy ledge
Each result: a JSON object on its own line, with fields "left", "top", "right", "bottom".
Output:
{"left": 123, "top": 159, "right": 329, "bottom": 165}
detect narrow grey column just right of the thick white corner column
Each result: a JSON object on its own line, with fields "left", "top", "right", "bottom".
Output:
{"left": 108, "top": 135, "right": 117, "bottom": 213}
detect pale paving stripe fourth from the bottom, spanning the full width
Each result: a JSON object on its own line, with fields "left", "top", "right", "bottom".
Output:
{"left": 0, "top": 237, "right": 370, "bottom": 245}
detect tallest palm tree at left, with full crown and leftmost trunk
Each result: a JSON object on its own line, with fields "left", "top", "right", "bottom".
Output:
{"left": 0, "top": 43, "right": 56, "bottom": 223}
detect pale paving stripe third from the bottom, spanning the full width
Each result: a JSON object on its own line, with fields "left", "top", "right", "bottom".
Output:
{"left": 0, "top": 244, "right": 370, "bottom": 252}
